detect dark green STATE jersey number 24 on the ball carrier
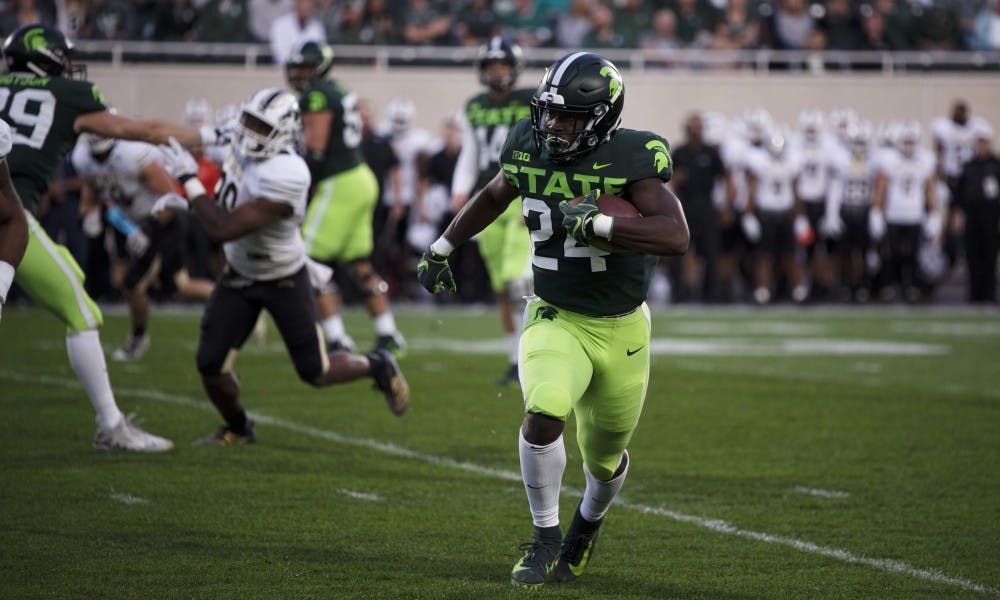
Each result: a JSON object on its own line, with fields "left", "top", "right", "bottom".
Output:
{"left": 500, "top": 119, "right": 673, "bottom": 316}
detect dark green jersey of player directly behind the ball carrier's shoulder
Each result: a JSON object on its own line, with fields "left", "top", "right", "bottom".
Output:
{"left": 465, "top": 89, "right": 534, "bottom": 190}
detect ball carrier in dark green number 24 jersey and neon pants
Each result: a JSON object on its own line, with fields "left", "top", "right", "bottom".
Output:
{"left": 417, "top": 52, "right": 690, "bottom": 587}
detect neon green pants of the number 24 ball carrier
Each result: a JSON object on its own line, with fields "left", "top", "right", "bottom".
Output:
{"left": 520, "top": 299, "right": 650, "bottom": 481}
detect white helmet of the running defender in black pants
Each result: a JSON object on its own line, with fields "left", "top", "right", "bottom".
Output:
{"left": 233, "top": 88, "right": 302, "bottom": 160}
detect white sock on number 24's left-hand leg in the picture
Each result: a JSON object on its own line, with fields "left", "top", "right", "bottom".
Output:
{"left": 517, "top": 430, "right": 566, "bottom": 527}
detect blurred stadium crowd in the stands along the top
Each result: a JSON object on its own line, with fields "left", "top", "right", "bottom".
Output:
{"left": 0, "top": 0, "right": 1000, "bottom": 53}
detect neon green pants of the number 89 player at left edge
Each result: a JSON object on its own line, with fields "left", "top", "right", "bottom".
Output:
{"left": 14, "top": 213, "right": 104, "bottom": 333}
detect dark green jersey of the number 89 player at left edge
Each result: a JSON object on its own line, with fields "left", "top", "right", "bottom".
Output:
{"left": 0, "top": 73, "right": 107, "bottom": 212}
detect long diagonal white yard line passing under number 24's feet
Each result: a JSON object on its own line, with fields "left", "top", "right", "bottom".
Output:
{"left": 0, "top": 370, "right": 1000, "bottom": 597}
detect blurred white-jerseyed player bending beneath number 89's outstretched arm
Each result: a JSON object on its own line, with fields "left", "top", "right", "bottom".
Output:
{"left": 71, "top": 133, "right": 212, "bottom": 361}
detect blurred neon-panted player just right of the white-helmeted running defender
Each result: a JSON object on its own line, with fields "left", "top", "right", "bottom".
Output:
{"left": 285, "top": 41, "right": 406, "bottom": 352}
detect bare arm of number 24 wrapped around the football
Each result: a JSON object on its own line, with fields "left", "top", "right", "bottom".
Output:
{"left": 611, "top": 179, "right": 691, "bottom": 256}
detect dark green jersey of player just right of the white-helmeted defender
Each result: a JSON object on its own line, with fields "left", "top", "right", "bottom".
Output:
{"left": 299, "top": 80, "right": 364, "bottom": 183}
